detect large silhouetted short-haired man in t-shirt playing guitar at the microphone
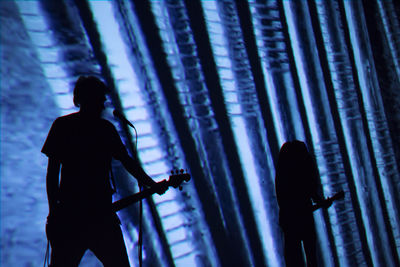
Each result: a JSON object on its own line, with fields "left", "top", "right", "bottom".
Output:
{"left": 42, "top": 76, "right": 166, "bottom": 267}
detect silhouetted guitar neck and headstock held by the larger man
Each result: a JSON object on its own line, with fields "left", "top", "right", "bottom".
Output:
{"left": 111, "top": 170, "right": 190, "bottom": 212}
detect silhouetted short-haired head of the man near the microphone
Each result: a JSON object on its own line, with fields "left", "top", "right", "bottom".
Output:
{"left": 74, "top": 76, "right": 107, "bottom": 116}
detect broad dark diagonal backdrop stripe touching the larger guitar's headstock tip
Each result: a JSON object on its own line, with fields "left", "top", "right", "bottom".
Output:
{"left": 128, "top": 0, "right": 243, "bottom": 266}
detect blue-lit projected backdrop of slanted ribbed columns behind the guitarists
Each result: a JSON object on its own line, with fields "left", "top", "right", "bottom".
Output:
{"left": 0, "top": 0, "right": 400, "bottom": 267}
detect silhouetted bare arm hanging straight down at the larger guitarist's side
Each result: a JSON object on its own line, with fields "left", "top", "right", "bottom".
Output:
{"left": 46, "top": 157, "right": 61, "bottom": 213}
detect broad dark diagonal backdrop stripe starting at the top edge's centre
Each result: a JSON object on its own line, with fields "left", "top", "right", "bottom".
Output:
{"left": 185, "top": 0, "right": 265, "bottom": 266}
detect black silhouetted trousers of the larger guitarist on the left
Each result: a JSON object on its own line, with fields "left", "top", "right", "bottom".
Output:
{"left": 50, "top": 220, "right": 130, "bottom": 267}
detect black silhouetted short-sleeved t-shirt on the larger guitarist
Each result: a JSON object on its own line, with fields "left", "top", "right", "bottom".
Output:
{"left": 42, "top": 112, "right": 127, "bottom": 219}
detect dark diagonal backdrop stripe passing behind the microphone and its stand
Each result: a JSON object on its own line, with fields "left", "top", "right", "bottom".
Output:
{"left": 70, "top": 0, "right": 175, "bottom": 266}
